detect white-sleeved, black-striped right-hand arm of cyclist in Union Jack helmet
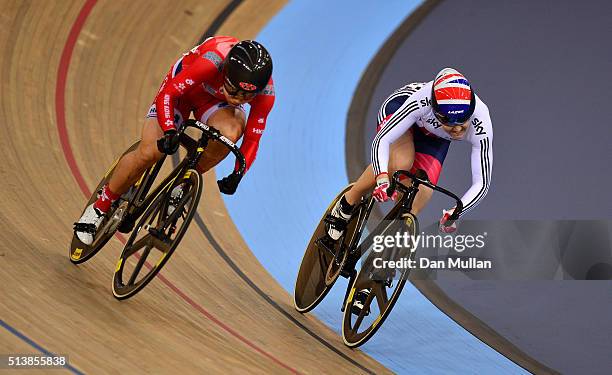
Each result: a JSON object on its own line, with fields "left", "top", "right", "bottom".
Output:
{"left": 461, "top": 127, "right": 493, "bottom": 216}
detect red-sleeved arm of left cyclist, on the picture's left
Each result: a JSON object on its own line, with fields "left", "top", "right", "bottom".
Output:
{"left": 155, "top": 52, "right": 222, "bottom": 131}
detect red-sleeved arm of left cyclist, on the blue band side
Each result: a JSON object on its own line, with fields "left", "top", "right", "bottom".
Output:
{"left": 236, "top": 83, "right": 275, "bottom": 172}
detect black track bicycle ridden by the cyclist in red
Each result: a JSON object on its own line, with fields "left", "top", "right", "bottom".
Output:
{"left": 70, "top": 119, "right": 246, "bottom": 299}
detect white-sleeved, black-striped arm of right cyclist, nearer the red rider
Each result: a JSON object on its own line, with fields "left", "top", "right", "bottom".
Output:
{"left": 372, "top": 97, "right": 419, "bottom": 177}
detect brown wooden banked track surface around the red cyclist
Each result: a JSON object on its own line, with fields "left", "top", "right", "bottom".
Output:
{"left": 0, "top": 0, "right": 388, "bottom": 373}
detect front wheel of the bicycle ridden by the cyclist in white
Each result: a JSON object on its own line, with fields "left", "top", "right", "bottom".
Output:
{"left": 342, "top": 213, "right": 418, "bottom": 348}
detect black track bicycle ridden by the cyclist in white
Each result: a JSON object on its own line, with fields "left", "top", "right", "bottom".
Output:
{"left": 294, "top": 170, "right": 463, "bottom": 347}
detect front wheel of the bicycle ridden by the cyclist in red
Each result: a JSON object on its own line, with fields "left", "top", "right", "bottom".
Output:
{"left": 112, "top": 169, "right": 203, "bottom": 300}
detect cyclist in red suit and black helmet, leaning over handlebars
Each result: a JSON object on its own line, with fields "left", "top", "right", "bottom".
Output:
{"left": 75, "top": 36, "right": 275, "bottom": 245}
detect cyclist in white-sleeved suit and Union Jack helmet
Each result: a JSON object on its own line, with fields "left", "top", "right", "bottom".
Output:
{"left": 327, "top": 68, "right": 493, "bottom": 240}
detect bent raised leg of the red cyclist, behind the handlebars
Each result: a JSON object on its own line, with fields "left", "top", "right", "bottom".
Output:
{"left": 198, "top": 103, "right": 246, "bottom": 173}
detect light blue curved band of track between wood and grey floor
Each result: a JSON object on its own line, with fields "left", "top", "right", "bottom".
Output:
{"left": 219, "top": 1, "right": 524, "bottom": 374}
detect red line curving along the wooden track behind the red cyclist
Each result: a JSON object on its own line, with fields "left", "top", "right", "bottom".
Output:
{"left": 55, "top": 0, "right": 299, "bottom": 374}
